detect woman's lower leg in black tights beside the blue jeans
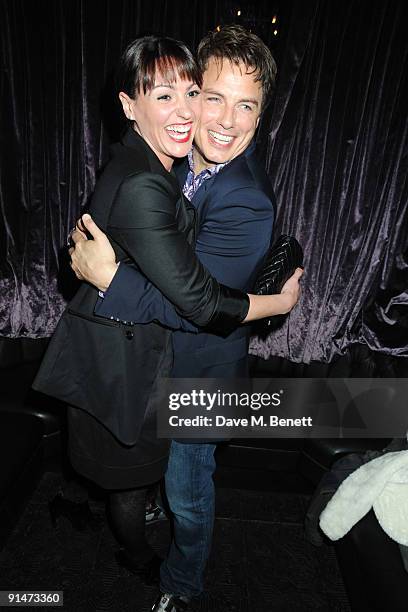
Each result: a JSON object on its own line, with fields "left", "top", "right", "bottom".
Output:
{"left": 107, "top": 488, "right": 154, "bottom": 563}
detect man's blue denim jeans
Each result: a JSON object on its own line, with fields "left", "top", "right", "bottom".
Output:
{"left": 160, "top": 441, "right": 216, "bottom": 597}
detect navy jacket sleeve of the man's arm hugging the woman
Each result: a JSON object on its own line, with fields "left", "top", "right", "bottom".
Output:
{"left": 95, "top": 184, "right": 273, "bottom": 333}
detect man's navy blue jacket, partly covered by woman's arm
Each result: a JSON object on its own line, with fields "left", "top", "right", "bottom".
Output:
{"left": 95, "top": 143, "right": 275, "bottom": 378}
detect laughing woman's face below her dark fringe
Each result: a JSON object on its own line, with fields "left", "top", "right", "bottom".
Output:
{"left": 119, "top": 73, "right": 201, "bottom": 170}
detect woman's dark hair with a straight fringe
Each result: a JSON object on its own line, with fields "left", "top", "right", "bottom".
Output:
{"left": 116, "top": 35, "right": 202, "bottom": 99}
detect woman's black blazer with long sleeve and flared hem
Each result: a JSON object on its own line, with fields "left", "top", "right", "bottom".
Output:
{"left": 33, "top": 130, "right": 248, "bottom": 450}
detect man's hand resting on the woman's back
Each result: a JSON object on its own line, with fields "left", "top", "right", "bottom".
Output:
{"left": 69, "top": 214, "right": 119, "bottom": 291}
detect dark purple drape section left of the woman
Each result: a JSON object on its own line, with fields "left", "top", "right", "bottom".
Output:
{"left": 0, "top": 0, "right": 115, "bottom": 338}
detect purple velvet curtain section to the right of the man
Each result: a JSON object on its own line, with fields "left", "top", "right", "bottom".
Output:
{"left": 251, "top": 0, "right": 408, "bottom": 363}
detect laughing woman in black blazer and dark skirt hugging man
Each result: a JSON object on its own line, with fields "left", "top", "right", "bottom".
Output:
{"left": 35, "top": 36, "right": 300, "bottom": 563}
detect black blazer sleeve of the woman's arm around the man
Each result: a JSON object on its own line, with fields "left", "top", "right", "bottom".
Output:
{"left": 108, "top": 173, "right": 249, "bottom": 334}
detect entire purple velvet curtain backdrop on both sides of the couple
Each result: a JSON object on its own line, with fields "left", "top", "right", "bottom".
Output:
{"left": 0, "top": 0, "right": 408, "bottom": 363}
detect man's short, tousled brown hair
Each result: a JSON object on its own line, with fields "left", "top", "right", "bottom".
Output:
{"left": 197, "top": 24, "right": 277, "bottom": 111}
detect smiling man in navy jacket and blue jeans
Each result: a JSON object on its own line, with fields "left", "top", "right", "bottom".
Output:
{"left": 72, "top": 26, "right": 300, "bottom": 612}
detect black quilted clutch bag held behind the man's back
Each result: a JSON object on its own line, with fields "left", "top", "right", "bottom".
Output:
{"left": 254, "top": 234, "right": 303, "bottom": 331}
